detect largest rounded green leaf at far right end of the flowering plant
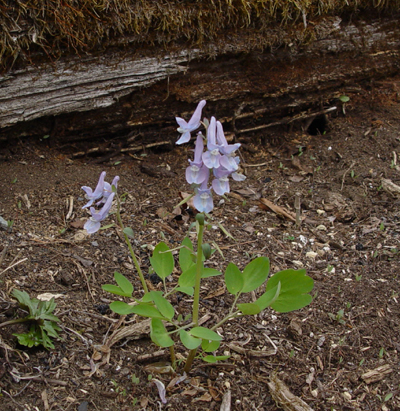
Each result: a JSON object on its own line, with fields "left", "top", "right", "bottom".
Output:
{"left": 266, "top": 269, "right": 314, "bottom": 313}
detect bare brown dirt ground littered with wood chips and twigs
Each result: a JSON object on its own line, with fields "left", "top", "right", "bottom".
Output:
{"left": 0, "top": 78, "right": 400, "bottom": 411}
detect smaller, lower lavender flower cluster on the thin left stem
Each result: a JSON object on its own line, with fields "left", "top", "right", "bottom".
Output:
{"left": 82, "top": 171, "right": 119, "bottom": 234}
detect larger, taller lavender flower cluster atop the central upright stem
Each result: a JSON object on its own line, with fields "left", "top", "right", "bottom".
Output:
{"left": 176, "top": 100, "right": 246, "bottom": 213}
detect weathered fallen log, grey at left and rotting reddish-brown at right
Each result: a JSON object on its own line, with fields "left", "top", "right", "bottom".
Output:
{"left": 0, "top": 15, "right": 400, "bottom": 146}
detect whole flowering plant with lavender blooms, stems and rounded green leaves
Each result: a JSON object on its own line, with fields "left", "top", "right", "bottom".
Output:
{"left": 82, "top": 100, "right": 313, "bottom": 378}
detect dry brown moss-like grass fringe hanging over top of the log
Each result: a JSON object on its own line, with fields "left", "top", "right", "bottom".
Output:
{"left": 0, "top": 0, "right": 400, "bottom": 70}
